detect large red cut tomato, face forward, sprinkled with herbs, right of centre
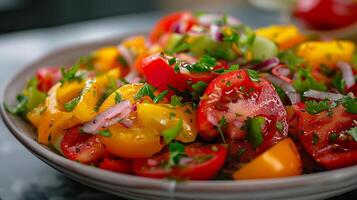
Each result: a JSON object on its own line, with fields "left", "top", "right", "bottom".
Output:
{"left": 197, "top": 70, "right": 288, "bottom": 162}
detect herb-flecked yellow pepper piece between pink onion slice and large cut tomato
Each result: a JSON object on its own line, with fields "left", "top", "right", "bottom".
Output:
{"left": 137, "top": 103, "right": 197, "bottom": 143}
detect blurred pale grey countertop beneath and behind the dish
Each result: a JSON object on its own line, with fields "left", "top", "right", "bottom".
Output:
{"left": 0, "top": 9, "right": 357, "bottom": 200}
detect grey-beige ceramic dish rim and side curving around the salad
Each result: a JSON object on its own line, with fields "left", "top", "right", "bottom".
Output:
{"left": 0, "top": 34, "right": 357, "bottom": 200}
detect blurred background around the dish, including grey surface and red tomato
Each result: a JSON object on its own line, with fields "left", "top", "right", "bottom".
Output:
{"left": 0, "top": 0, "right": 357, "bottom": 200}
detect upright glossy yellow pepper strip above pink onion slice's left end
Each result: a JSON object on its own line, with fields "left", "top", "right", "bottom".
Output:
{"left": 72, "top": 79, "right": 99, "bottom": 122}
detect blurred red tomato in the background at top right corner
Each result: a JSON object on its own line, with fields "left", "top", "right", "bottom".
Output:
{"left": 294, "top": 0, "right": 357, "bottom": 30}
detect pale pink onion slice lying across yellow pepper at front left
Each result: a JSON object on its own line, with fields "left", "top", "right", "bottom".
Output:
{"left": 82, "top": 100, "right": 132, "bottom": 134}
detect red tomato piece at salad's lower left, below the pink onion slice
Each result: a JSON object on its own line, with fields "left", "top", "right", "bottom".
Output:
{"left": 61, "top": 126, "right": 105, "bottom": 163}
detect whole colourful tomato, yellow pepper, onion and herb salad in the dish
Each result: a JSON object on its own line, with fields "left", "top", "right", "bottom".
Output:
{"left": 6, "top": 12, "right": 357, "bottom": 180}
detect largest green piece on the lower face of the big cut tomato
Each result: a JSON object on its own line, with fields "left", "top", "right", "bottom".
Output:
{"left": 246, "top": 116, "right": 265, "bottom": 148}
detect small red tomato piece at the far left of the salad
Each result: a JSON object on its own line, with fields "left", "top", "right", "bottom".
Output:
{"left": 36, "top": 67, "right": 62, "bottom": 92}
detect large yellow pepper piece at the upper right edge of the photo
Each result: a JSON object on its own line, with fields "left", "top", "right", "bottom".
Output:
{"left": 297, "top": 40, "right": 355, "bottom": 68}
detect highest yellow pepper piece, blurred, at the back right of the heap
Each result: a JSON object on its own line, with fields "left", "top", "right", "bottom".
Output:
{"left": 255, "top": 25, "right": 305, "bottom": 50}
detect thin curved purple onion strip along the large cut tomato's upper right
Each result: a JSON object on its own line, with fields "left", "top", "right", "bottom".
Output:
{"left": 265, "top": 74, "right": 301, "bottom": 105}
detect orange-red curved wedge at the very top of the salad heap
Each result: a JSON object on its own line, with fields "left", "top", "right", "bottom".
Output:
{"left": 150, "top": 11, "right": 197, "bottom": 43}
